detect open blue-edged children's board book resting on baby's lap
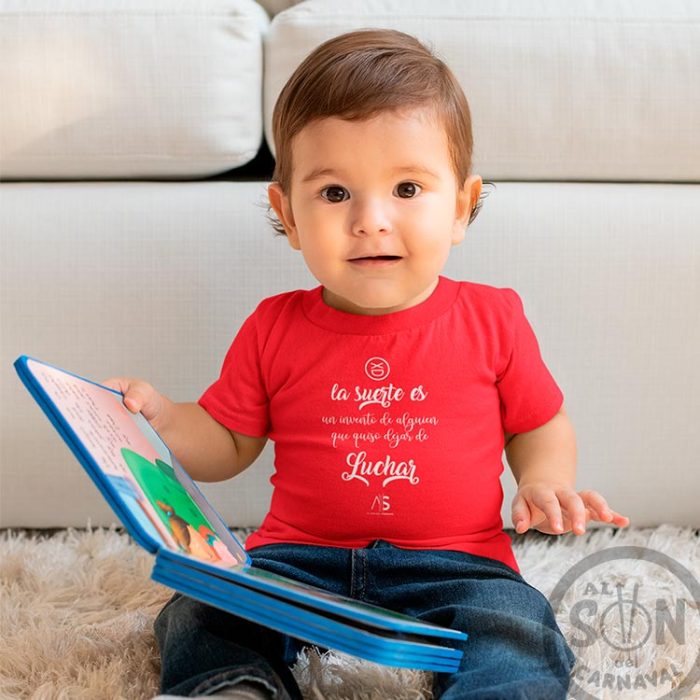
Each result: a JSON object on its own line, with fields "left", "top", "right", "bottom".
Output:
{"left": 14, "top": 355, "right": 467, "bottom": 672}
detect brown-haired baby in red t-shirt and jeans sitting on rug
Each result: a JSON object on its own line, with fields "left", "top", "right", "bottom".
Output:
{"left": 105, "top": 30, "right": 629, "bottom": 700}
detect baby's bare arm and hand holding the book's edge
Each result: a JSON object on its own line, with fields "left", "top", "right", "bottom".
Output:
{"left": 102, "top": 377, "right": 267, "bottom": 481}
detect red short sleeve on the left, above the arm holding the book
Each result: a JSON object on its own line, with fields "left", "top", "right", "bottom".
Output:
{"left": 198, "top": 313, "right": 270, "bottom": 437}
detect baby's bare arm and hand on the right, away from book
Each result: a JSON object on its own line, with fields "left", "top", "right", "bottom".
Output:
{"left": 505, "top": 406, "right": 629, "bottom": 535}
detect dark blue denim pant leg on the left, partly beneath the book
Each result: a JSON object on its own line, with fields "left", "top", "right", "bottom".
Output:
{"left": 154, "top": 544, "right": 349, "bottom": 700}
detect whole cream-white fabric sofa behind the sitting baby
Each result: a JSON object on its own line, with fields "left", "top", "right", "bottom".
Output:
{"left": 0, "top": 0, "right": 700, "bottom": 528}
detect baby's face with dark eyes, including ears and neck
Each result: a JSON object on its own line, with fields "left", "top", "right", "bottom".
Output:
{"left": 268, "top": 109, "right": 481, "bottom": 314}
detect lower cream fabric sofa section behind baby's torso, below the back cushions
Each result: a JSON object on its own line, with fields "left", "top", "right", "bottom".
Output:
{"left": 0, "top": 182, "right": 700, "bottom": 527}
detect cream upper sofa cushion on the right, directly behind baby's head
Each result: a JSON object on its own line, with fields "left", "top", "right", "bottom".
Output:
{"left": 264, "top": 0, "right": 700, "bottom": 182}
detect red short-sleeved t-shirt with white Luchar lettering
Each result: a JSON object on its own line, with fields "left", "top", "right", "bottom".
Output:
{"left": 199, "top": 276, "right": 563, "bottom": 571}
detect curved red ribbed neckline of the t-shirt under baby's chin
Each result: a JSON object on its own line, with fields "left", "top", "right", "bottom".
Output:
{"left": 303, "top": 275, "right": 459, "bottom": 335}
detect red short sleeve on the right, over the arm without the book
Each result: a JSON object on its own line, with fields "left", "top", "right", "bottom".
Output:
{"left": 496, "top": 289, "right": 564, "bottom": 434}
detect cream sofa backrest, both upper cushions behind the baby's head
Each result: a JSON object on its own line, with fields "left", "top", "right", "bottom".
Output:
{"left": 0, "top": 0, "right": 700, "bottom": 182}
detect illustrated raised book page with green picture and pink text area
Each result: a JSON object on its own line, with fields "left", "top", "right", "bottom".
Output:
{"left": 27, "top": 359, "right": 247, "bottom": 567}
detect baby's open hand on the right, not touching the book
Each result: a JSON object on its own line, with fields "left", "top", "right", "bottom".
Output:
{"left": 511, "top": 482, "right": 630, "bottom": 535}
